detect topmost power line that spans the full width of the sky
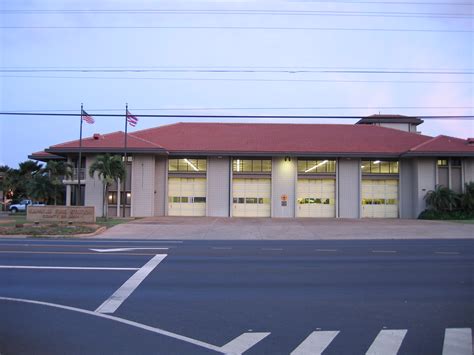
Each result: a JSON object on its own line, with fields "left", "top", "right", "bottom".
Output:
{"left": 0, "top": 9, "right": 473, "bottom": 19}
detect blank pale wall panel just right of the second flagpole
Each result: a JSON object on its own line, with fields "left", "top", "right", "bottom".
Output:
{"left": 131, "top": 155, "right": 156, "bottom": 217}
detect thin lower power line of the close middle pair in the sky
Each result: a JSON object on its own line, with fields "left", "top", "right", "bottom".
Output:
{"left": 0, "top": 75, "right": 472, "bottom": 84}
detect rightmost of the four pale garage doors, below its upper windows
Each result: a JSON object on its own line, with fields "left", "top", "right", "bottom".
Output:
{"left": 362, "top": 179, "right": 398, "bottom": 218}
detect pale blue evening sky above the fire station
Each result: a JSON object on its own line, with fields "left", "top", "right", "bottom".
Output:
{"left": 0, "top": 0, "right": 474, "bottom": 167}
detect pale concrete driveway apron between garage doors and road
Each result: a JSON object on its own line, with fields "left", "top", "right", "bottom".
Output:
{"left": 98, "top": 217, "right": 474, "bottom": 240}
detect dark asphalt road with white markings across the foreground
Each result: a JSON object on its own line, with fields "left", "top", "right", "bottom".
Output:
{"left": 0, "top": 239, "right": 474, "bottom": 355}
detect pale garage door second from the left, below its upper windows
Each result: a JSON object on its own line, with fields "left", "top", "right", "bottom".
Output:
{"left": 232, "top": 179, "right": 271, "bottom": 217}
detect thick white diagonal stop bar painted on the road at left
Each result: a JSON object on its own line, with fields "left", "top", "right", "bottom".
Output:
{"left": 95, "top": 254, "right": 167, "bottom": 313}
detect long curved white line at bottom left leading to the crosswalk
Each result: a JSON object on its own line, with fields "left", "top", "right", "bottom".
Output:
{"left": 0, "top": 297, "right": 223, "bottom": 353}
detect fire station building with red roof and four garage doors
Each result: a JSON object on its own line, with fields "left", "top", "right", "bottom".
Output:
{"left": 30, "top": 115, "right": 474, "bottom": 218}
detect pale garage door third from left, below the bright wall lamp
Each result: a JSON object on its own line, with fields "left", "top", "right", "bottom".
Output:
{"left": 296, "top": 179, "right": 336, "bottom": 218}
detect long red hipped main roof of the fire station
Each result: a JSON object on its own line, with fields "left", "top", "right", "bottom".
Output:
{"left": 41, "top": 123, "right": 474, "bottom": 156}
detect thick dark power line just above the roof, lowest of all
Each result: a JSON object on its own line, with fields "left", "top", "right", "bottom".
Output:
{"left": 0, "top": 111, "right": 474, "bottom": 120}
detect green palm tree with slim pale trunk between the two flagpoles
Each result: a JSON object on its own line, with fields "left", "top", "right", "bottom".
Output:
{"left": 89, "top": 154, "right": 126, "bottom": 219}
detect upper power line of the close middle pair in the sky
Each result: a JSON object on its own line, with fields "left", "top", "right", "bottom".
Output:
{"left": 0, "top": 68, "right": 474, "bottom": 75}
